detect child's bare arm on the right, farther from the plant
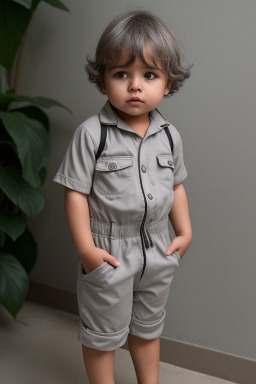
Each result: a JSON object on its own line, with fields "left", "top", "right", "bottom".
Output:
{"left": 166, "top": 184, "right": 192, "bottom": 257}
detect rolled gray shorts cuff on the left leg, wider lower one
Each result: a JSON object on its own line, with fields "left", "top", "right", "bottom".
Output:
{"left": 78, "top": 321, "right": 129, "bottom": 351}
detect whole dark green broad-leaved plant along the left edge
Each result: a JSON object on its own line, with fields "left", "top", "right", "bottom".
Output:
{"left": 0, "top": 0, "right": 68, "bottom": 318}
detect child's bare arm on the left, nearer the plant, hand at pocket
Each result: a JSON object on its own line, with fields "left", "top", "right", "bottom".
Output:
{"left": 64, "top": 188, "right": 120, "bottom": 273}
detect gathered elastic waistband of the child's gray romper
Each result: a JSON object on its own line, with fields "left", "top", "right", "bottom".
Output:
{"left": 90, "top": 217, "right": 169, "bottom": 238}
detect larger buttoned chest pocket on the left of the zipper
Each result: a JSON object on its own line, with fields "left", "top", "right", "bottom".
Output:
{"left": 94, "top": 156, "right": 133, "bottom": 198}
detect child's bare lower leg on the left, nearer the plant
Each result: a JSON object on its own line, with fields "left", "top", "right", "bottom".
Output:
{"left": 82, "top": 345, "right": 115, "bottom": 384}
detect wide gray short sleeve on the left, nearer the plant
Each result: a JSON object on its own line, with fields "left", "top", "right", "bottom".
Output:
{"left": 53, "top": 126, "right": 95, "bottom": 194}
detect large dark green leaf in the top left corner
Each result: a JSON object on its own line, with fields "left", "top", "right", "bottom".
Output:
{"left": 0, "top": 0, "right": 30, "bottom": 69}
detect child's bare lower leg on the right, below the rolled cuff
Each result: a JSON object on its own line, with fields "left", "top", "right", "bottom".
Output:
{"left": 128, "top": 335, "right": 160, "bottom": 384}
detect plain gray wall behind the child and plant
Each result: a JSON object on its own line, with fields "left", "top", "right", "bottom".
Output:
{"left": 20, "top": 0, "right": 256, "bottom": 359}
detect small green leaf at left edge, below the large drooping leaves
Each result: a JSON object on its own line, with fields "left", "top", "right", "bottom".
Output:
{"left": 0, "top": 212, "right": 26, "bottom": 241}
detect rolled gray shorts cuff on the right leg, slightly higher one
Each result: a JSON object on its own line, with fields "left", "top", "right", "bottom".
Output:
{"left": 129, "top": 310, "right": 166, "bottom": 340}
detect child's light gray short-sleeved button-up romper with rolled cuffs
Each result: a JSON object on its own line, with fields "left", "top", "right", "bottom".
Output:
{"left": 54, "top": 102, "right": 187, "bottom": 351}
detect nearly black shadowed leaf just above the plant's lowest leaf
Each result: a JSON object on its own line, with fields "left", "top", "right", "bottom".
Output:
{"left": 4, "top": 229, "right": 37, "bottom": 275}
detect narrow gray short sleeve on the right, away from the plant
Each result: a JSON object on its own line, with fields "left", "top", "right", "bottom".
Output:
{"left": 171, "top": 126, "right": 188, "bottom": 185}
